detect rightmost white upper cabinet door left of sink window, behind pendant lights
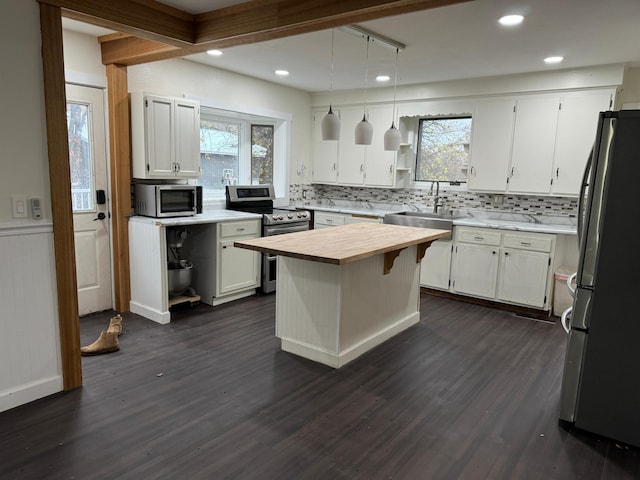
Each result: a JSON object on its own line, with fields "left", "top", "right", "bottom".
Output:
{"left": 362, "top": 106, "right": 396, "bottom": 187}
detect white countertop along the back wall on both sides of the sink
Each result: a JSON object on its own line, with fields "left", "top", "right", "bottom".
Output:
{"left": 296, "top": 201, "right": 577, "bottom": 235}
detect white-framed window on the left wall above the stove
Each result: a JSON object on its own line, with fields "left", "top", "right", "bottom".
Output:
{"left": 196, "top": 109, "right": 276, "bottom": 202}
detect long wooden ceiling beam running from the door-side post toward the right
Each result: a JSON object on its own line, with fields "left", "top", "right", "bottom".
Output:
{"left": 91, "top": 0, "right": 474, "bottom": 65}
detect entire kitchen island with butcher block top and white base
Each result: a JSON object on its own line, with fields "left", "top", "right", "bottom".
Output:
{"left": 234, "top": 223, "right": 451, "bottom": 368}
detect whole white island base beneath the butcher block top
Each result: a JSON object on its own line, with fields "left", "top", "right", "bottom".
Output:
{"left": 276, "top": 246, "right": 420, "bottom": 368}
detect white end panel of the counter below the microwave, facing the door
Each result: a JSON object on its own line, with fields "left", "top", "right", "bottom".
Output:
{"left": 129, "top": 220, "right": 171, "bottom": 324}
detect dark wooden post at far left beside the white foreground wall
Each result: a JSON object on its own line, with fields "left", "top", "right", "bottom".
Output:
{"left": 40, "top": 3, "right": 82, "bottom": 390}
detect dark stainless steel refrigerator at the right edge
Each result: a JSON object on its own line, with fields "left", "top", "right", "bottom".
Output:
{"left": 560, "top": 110, "right": 640, "bottom": 446}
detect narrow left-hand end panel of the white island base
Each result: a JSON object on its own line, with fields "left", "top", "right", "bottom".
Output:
{"left": 276, "top": 257, "right": 341, "bottom": 366}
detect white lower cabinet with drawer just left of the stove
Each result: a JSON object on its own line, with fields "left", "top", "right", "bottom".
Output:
{"left": 213, "top": 220, "right": 261, "bottom": 305}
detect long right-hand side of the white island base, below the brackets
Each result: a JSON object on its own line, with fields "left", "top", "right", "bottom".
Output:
{"left": 339, "top": 246, "right": 420, "bottom": 365}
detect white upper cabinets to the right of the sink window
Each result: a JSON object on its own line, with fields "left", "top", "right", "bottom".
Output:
{"left": 468, "top": 89, "right": 615, "bottom": 196}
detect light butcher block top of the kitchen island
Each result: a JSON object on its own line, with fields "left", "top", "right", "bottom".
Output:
{"left": 234, "top": 223, "right": 451, "bottom": 265}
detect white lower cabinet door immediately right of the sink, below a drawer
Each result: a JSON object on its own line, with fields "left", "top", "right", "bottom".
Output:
{"left": 452, "top": 243, "right": 499, "bottom": 298}
